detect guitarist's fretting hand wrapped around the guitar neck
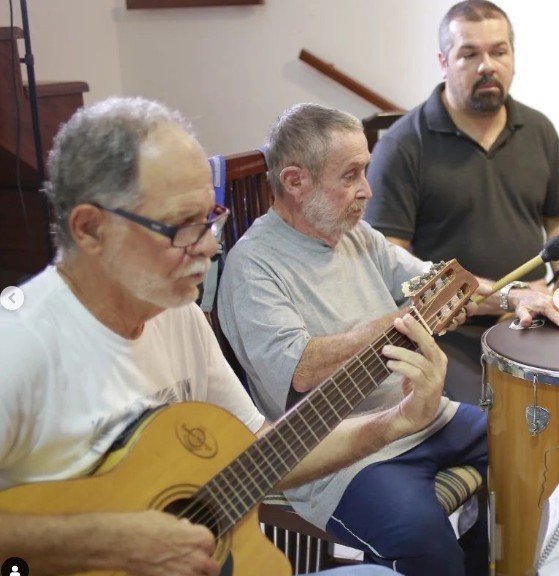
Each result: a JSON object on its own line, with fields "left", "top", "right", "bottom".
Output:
{"left": 382, "top": 314, "right": 447, "bottom": 435}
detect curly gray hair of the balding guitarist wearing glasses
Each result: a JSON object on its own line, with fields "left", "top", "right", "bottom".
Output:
{"left": 45, "top": 97, "right": 192, "bottom": 249}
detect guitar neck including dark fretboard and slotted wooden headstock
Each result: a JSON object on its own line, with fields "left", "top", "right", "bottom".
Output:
{"left": 196, "top": 260, "right": 477, "bottom": 533}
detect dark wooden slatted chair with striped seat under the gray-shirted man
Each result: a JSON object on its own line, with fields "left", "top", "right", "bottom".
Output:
{"left": 206, "top": 150, "right": 482, "bottom": 574}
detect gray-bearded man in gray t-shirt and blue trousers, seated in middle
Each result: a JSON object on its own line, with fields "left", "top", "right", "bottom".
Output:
{"left": 218, "top": 104, "right": 487, "bottom": 576}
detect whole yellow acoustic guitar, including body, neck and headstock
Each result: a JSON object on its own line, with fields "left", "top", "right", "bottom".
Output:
{"left": 0, "top": 260, "right": 477, "bottom": 576}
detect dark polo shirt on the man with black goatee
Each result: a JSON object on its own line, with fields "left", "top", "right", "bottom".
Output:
{"left": 365, "top": 84, "right": 559, "bottom": 279}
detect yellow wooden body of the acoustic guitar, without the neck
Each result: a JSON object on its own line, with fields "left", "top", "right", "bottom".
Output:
{"left": 0, "top": 402, "right": 291, "bottom": 576}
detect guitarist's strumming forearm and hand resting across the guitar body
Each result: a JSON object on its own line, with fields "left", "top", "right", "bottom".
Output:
{"left": 0, "top": 510, "right": 218, "bottom": 576}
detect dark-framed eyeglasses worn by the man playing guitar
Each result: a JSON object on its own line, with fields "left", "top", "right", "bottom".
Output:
{"left": 92, "top": 202, "right": 230, "bottom": 248}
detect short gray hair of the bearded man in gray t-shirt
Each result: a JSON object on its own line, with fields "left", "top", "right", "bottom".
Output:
{"left": 266, "top": 103, "right": 363, "bottom": 196}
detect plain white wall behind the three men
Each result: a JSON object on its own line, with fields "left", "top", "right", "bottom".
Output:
{"left": 0, "top": 0, "right": 559, "bottom": 154}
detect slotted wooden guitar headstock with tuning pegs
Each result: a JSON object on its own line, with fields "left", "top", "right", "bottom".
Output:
{"left": 402, "top": 259, "right": 478, "bottom": 334}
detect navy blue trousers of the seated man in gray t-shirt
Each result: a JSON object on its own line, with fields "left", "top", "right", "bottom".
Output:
{"left": 326, "top": 404, "right": 487, "bottom": 576}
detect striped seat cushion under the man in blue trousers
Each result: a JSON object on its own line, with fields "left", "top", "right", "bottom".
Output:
{"left": 264, "top": 466, "right": 483, "bottom": 516}
